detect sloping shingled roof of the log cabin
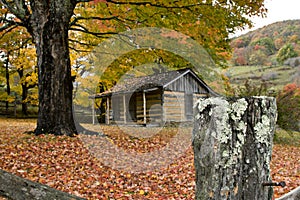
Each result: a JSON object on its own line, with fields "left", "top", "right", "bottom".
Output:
{"left": 94, "top": 68, "right": 217, "bottom": 98}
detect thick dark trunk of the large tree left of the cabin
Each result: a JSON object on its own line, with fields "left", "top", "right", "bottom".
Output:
{"left": 29, "top": 0, "right": 77, "bottom": 135}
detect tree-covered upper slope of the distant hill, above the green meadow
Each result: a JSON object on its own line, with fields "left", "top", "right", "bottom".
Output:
{"left": 230, "top": 20, "right": 300, "bottom": 66}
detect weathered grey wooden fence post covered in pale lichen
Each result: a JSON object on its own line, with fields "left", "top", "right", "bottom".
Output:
{"left": 193, "top": 97, "right": 277, "bottom": 200}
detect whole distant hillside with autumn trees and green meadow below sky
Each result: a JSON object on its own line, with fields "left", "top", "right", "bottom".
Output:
{"left": 224, "top": 20, "right": 300, "bottom": 91}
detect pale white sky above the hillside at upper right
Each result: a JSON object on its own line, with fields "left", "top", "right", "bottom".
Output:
{"left": 237, "top": 0, "right": 300, "bottom": 35}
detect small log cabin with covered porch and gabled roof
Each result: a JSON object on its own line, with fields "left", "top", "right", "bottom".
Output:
{"left": 93, "top": 68, "right": 218, "bottom": 125}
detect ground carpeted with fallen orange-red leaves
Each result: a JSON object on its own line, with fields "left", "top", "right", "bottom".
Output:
{"left": 0, "top": 118, "right": 300, "bottom": 199}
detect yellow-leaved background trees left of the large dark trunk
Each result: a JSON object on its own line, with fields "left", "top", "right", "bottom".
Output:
{"left": 0, "top": 22, "right": 37, "bottom": 115}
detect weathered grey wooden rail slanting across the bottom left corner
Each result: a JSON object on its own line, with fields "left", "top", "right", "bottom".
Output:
{"left": 0, "top": 169, "right": 83, "bottom": 200}
